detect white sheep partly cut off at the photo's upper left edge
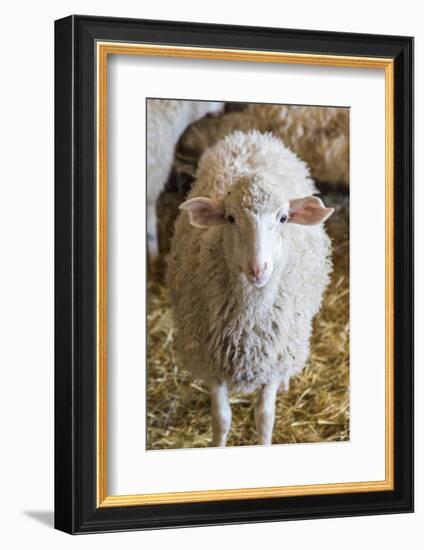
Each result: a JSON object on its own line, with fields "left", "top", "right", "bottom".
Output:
{"left": 147, "top": 99, "right": 223, "bottom": 263}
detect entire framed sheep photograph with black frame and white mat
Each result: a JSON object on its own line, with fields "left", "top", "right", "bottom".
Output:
{"left": 55, "top": 16, "right": 413, "bottom": 534}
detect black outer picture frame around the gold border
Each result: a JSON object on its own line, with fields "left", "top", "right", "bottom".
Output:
{"left": 55, "top": 15, "right": 413, "bottom": 534}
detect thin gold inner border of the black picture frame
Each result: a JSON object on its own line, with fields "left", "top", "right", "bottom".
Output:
{"left": 96, "top": 41, "right": 394, "bottom": 508}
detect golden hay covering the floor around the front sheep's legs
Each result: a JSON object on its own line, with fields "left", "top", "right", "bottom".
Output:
{"left": 147, "top": 192, "right": 349, "bottom": 449}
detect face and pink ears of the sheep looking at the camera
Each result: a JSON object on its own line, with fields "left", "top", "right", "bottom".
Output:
{"left": 180, "top": 191, "right": 333, "bottom": 288}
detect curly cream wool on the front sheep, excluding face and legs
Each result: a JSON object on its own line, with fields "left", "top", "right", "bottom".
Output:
{"left": 167, "top": 131, "right": 331, "bottom": 393}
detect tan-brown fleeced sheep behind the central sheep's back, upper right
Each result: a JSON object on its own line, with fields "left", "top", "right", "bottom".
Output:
{"left": 180, "top": 103, "right": 349, "bottom": 189}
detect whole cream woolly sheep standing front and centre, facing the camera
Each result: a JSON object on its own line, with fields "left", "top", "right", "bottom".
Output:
{"left": 167, "top": 131, "right": 333, "bottom": 446}
